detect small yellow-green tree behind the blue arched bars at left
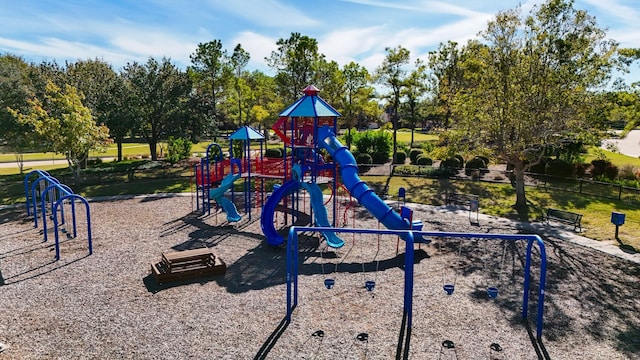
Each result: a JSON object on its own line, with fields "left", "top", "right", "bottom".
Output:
{"left": 10, "top": 82, "right": 109, "bottom": 183}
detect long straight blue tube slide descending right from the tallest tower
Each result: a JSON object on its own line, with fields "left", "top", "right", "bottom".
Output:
{"left": 318, "top": 126, "right": 428, "bottom": 243}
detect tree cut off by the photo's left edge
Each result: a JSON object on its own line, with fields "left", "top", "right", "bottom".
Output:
{"left": 0, "top": 55, "right": 37, "bottom": 174}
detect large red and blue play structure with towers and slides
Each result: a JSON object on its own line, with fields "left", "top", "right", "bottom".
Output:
{"left": 194, "top": 85, "right": 428, "bottom": 248}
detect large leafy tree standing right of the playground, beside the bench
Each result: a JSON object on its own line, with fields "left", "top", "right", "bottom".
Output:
{"left": 444, "top": 0, "right": 616, "bottom": 216}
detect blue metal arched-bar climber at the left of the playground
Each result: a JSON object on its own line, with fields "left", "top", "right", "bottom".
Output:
{"left": 24, "top": 170, "right": 93, "bottom": 260}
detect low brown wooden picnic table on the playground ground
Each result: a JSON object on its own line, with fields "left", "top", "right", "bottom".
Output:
{"left": 151, "top": 247, "right": 227, "bottom": 284}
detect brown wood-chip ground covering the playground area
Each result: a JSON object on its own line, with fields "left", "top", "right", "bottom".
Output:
{"left": 0, "top": 197, "right": 640, "bottom": 360}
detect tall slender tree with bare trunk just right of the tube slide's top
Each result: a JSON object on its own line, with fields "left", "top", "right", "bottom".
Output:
{"left": 375, "top": 46, "right": 410, "bottom": 159}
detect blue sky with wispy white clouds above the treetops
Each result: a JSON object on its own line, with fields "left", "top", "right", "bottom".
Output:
{"left": 0, "top": 0, "right": 640, "bottom": 83}
